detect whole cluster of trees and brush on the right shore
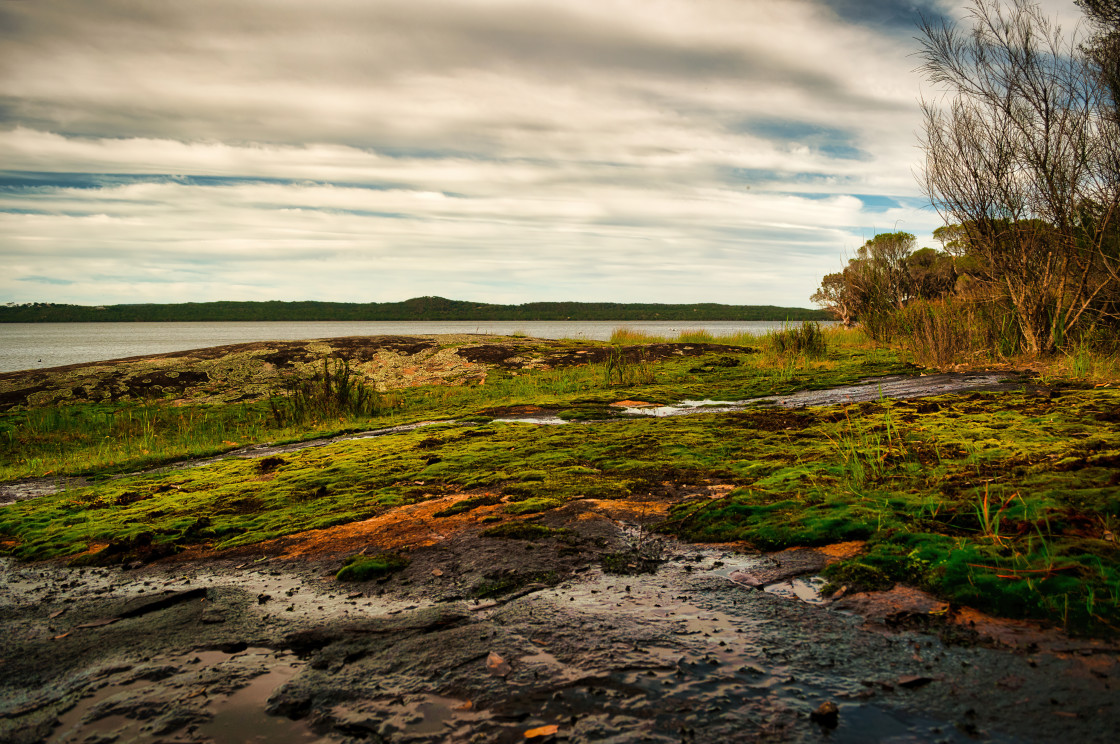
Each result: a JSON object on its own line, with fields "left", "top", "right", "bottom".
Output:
{"left": 812, "top": 0, "right": 1120, "bottom": 363}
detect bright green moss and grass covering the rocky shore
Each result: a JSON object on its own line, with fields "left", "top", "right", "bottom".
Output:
{"left": 0, "top": 328, "right": 1120, "bottom": 634}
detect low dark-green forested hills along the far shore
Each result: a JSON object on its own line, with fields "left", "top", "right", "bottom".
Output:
{"left": 0, "top": 297, "right": 829, "bottom": 323}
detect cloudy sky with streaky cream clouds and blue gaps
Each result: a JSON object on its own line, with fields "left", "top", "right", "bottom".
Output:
{"left": 0, "top": 0, "right": 1080, "bottom": 307}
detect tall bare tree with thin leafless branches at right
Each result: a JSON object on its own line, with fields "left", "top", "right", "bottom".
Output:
{"left": 921, "top": 0, "right": 1120, "bottom": 353}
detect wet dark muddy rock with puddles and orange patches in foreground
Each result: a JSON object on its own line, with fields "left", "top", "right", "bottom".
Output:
{"left": 0, "top": 496, "right": 1120, "bottom": 744}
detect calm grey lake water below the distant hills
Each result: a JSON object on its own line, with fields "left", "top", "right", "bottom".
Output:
{"left": 0, "top": 320, "right": 824, "bottom": 372}
